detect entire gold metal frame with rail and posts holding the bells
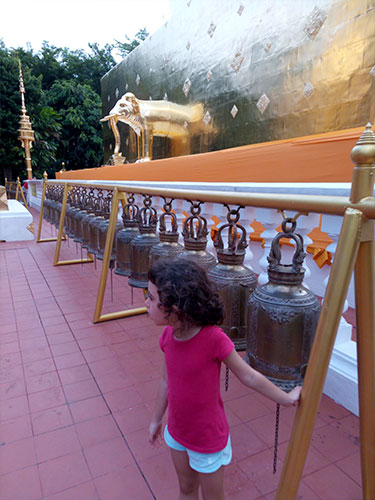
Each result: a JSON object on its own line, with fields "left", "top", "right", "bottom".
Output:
{"left": 41, "top": 124, "right": 375, "bottom": 500}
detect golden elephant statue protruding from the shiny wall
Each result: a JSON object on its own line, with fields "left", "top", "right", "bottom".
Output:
{"left": 101, "top": 92, "right": 212, "bottom": 163}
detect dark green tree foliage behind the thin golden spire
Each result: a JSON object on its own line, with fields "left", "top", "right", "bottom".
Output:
{"left": 0, "top": 28, "right": 148, "bottom": 183}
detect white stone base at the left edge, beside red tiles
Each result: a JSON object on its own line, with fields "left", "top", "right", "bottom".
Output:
{"left": 0, "top": 200, "right": 34, "bottom": 241}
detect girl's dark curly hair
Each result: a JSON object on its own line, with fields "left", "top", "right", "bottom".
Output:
{"left": 148, "top": 259, "right": 224, "bottom": 326}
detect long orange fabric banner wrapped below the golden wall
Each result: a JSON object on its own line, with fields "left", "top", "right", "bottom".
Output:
{"left": 56, "top": 127, "right": 364, "bottom": 182}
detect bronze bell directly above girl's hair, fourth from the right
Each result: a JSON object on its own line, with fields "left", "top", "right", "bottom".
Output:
{"left": 150, "top": 198, "right": 184, "bottom": 266}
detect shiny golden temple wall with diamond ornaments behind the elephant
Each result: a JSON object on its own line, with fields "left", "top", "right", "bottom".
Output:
{"left": 102, "top": 0, "right": 375, "bottom": 162}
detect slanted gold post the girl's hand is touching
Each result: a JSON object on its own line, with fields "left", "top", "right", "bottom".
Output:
{"left": 276, "top": 208, "right": 362, "bottom": 500}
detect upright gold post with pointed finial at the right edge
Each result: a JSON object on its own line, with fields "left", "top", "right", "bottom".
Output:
{"left": 350, "top": 124, "right": 375, "bottom": 500}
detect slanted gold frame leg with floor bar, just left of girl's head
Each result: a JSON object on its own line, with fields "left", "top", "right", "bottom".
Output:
{"left": 93, "top": 188, "right": 147, "bottom": 323}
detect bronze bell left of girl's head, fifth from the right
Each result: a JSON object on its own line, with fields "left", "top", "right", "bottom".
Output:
{"left": 129, "top": 195, "right": 160, "bottom": 288}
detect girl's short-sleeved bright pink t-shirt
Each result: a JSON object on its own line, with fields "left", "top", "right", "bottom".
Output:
{"left": 159, "top": 326, "right": 234, "bottom": 453}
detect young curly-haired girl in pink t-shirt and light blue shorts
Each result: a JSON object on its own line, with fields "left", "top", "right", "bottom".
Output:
{"left": 146, "top": 259, "right": 301, "bottom": 500}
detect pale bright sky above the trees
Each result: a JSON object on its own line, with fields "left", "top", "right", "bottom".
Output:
{"left": 0, "top": 0, "right": 170, "bottom": 60}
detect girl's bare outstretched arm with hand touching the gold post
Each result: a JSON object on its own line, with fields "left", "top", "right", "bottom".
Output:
{"left": 224, "top": 350, "right": 302, "bottom": 406}
